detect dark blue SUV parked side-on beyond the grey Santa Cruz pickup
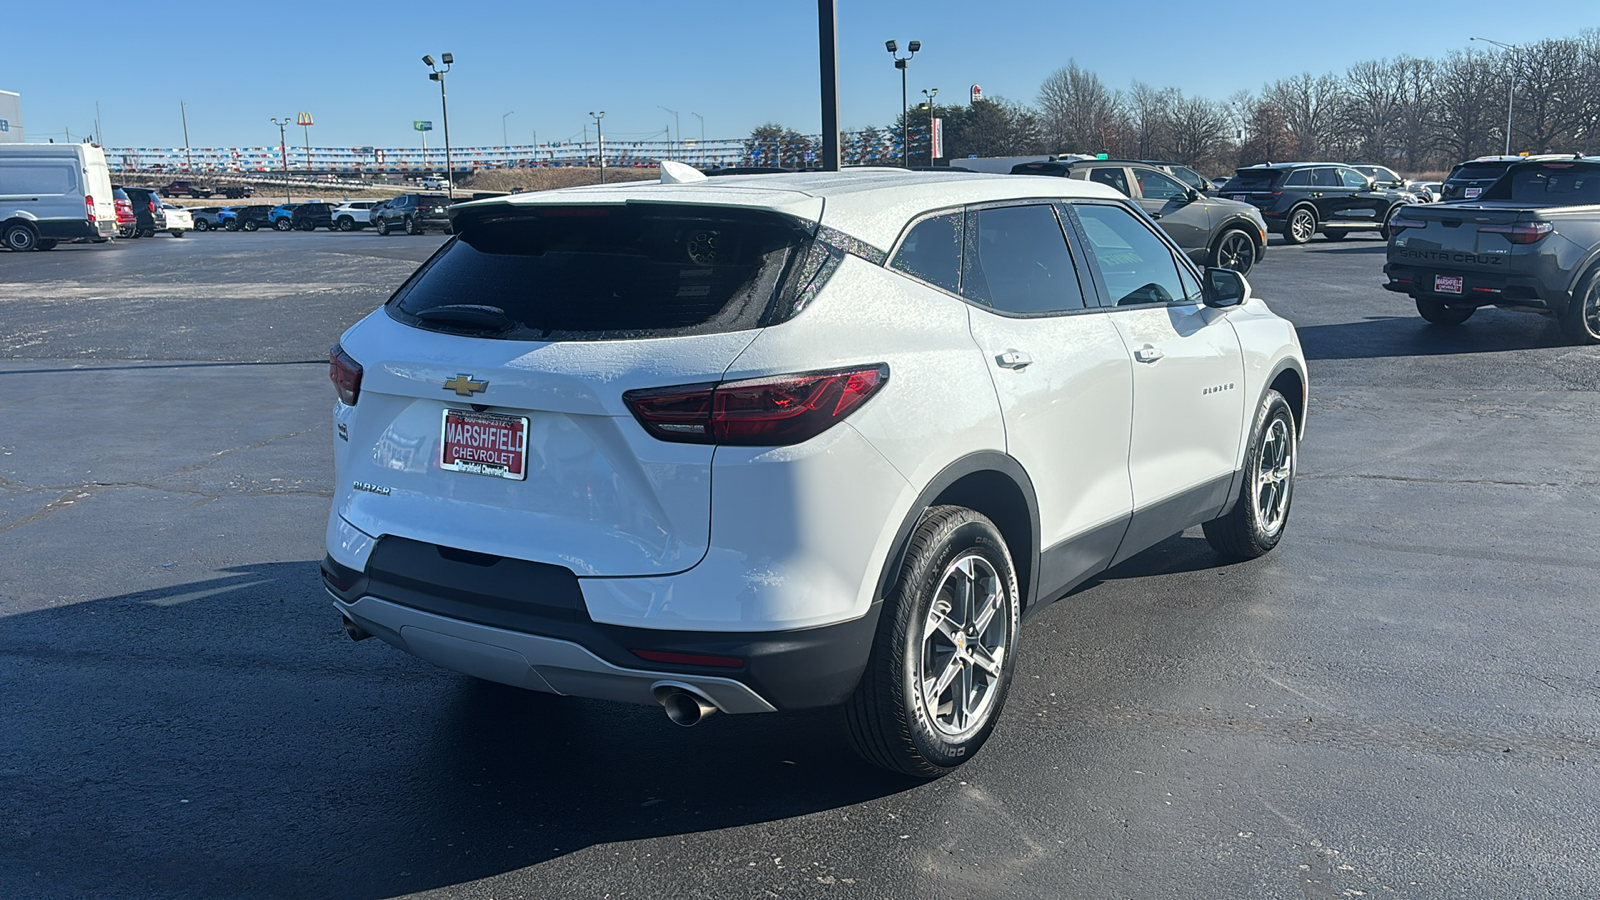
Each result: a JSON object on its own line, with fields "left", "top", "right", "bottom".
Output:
{"left": 1222, "top": 162, "right": 1416, "bottom": 243}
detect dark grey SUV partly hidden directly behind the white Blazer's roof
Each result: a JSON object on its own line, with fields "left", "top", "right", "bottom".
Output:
{"left": 1011, "top": 159, "right": 1267, "bottom": 274}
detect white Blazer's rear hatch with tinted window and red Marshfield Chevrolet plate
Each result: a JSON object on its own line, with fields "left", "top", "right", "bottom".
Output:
{"left": 336, "top": 203, "right": 819, "bottom": 575}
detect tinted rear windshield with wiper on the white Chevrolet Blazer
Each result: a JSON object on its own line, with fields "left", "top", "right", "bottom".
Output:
{"left": 387, "top": 205, "right": 808, "bottom": 341}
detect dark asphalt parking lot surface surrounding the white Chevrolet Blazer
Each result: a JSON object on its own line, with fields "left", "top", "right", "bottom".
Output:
{"left": 0, "top": 232, "right": 1600, "bottom": 900}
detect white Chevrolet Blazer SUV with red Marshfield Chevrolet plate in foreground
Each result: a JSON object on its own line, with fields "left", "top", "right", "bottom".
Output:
{"left": 323, "top": 171, "right": 1307, "bottom": 777}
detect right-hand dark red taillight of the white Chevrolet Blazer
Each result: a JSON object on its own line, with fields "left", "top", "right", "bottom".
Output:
{"left": 622, "top": 362, "right": 890, "bottom": 447}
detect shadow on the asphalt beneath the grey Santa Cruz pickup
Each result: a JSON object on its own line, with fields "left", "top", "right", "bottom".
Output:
{"left": 1294, "top": 312, "right": 1566, "bottom": 360}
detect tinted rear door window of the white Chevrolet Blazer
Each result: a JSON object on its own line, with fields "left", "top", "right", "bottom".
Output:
{"left": 962, "top": 207, "right": 1083, "bottom": 314}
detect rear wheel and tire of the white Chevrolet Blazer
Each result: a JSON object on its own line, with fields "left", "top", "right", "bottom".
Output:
{"left": 845, "top": 506, "right": 1021, "bottom": 778}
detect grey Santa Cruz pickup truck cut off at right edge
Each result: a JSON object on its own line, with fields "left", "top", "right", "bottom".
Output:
{"left": 1384, "top": 157, "right": 1600, "bottom": 344}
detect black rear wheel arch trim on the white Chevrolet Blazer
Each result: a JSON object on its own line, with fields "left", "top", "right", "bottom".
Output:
{"left": 877, "top": 452, "right": 1038, "bottom": 609}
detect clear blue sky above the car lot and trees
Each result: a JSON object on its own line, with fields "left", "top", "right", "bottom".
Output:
{"left": 0, "top": 0, "right": 1600, "bottom": 147}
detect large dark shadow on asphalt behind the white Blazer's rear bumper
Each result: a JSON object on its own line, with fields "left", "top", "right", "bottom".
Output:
{"left": 0, "top": 560, "right": 917, "bottom": 898}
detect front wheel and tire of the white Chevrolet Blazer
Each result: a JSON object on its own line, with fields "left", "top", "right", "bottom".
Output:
{"left": 1202, "top": 391, "right": 1299, "bottom": 559}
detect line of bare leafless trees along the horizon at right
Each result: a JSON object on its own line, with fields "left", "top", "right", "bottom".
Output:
{"left": 746, "top": 29, "right": 1600, "bottom": 173}
